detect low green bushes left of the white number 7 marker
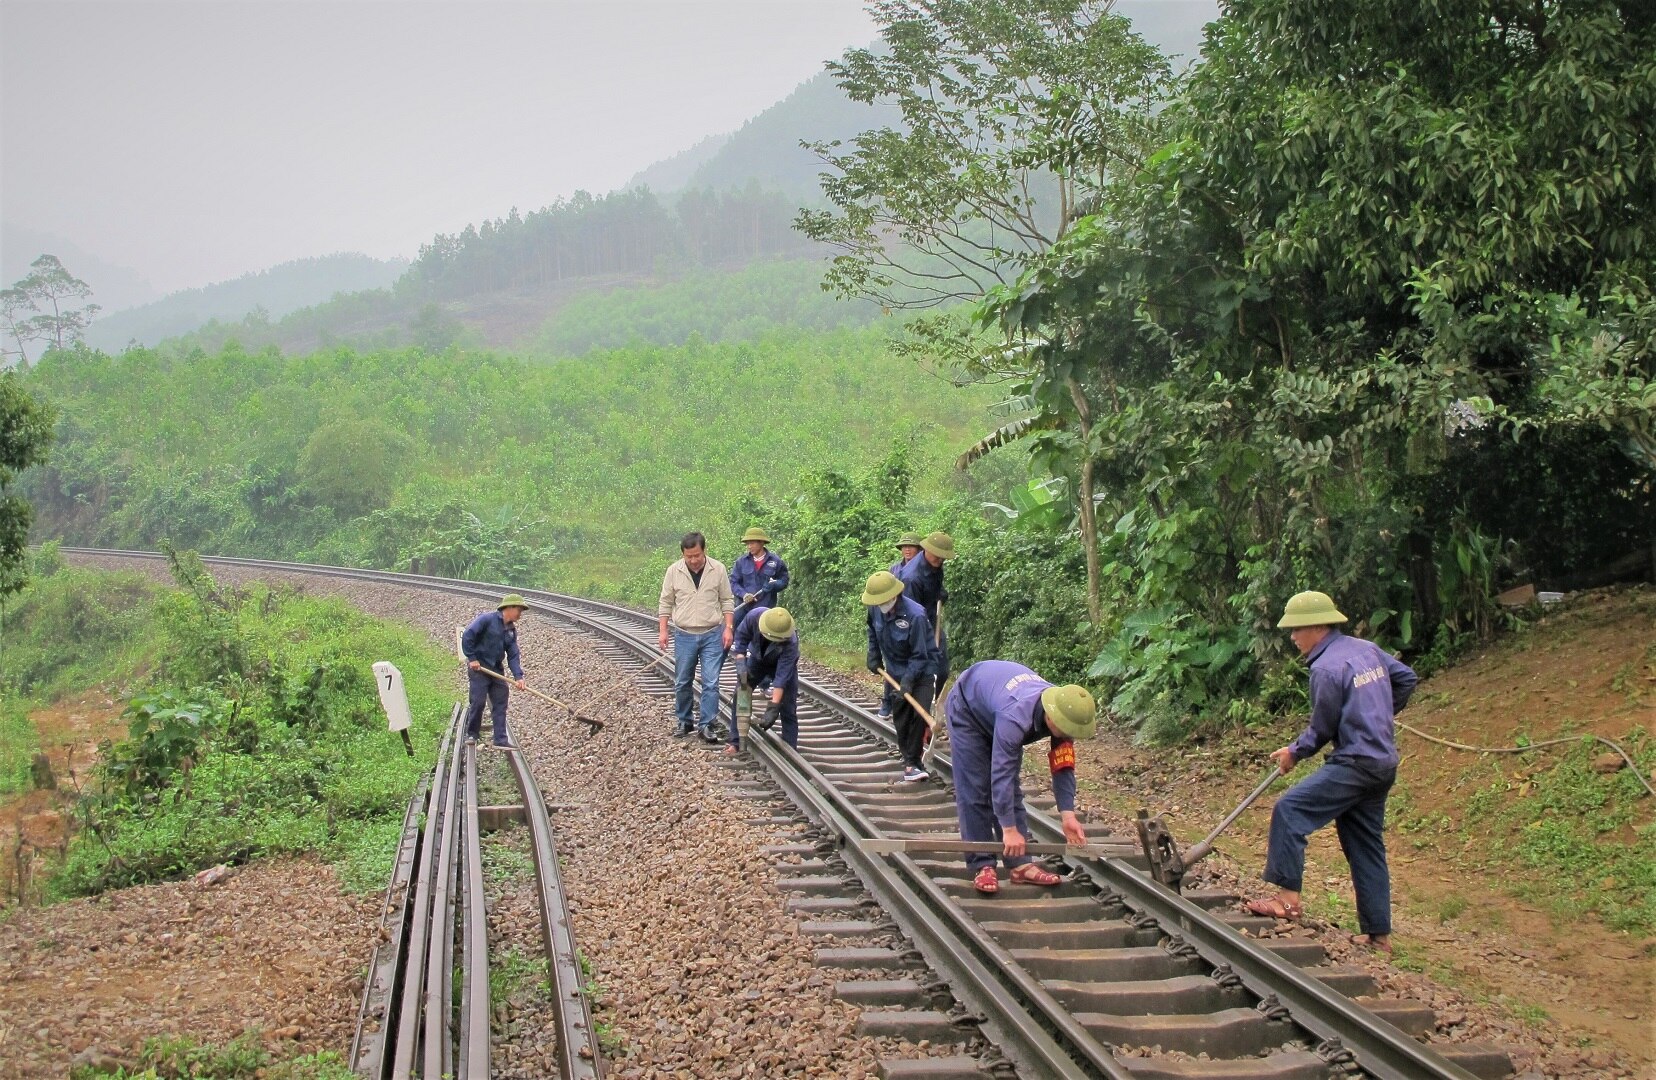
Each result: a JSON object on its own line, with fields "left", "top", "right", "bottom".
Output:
{"left": 0, "top": 553, "right": 452, "bottom": 894}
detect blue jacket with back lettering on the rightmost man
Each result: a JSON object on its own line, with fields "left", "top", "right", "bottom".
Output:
{"left": 1290, "top": 629, "right": 1419, "bottom": 769}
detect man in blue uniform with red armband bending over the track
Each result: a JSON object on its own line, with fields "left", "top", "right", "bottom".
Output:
{"left": 944, "top": 659, "right": 1098, "bottom": 896}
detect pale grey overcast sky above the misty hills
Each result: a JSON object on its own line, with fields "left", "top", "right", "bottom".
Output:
{"left": 0, "top": 0, "right": 876, "bottom": 292}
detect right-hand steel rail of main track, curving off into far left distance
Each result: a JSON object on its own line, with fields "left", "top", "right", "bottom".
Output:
{"left": 63, "top": 548, "right": 1474, "bottom": 1080}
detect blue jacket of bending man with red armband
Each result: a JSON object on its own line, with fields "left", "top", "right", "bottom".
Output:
{"left": 944, "top": 659, "right": 1075, "bottom": 825}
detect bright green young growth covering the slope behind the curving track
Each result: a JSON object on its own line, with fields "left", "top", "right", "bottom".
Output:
{"left": 12, "top": 330, "right": 985, "bottom": 583}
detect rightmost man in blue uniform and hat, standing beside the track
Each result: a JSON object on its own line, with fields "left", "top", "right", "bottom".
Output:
{"left": 1247, "top": 591, "right": 1419, "bottom": 952}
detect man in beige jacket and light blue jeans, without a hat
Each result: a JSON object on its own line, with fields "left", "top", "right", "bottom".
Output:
{"left": 656, "top": 532, "right": 735, "bottom": 742}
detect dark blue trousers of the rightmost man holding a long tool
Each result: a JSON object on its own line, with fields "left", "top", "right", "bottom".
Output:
{"left": 1265, "top": 759, "right": 1398, "bottom": 934}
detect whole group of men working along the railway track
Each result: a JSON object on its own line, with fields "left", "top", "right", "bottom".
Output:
{"left": 462, "top": 527, "right": 1416, "bottom": 951}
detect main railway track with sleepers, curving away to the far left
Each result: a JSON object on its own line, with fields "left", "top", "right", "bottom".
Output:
{"left": 66, "top": 548, "right": 1510, "bottom": 1080}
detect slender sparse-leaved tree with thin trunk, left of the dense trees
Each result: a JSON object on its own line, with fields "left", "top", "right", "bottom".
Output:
{"left": 798, "top": 0, "right": 1171, "bottom": 624}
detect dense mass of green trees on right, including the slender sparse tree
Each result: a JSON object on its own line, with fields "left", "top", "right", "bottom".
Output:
{"left": 800, "top": 0, "right": 1656, "bottom": 737}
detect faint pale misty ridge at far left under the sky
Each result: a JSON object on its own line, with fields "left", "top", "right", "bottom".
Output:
{"left": 86, "top": 252, "right": 409, "bottom": 351}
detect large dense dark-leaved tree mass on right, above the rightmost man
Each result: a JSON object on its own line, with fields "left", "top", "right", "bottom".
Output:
{"left": 985, "top": 0, "right": 1656, "bottom": 730}
